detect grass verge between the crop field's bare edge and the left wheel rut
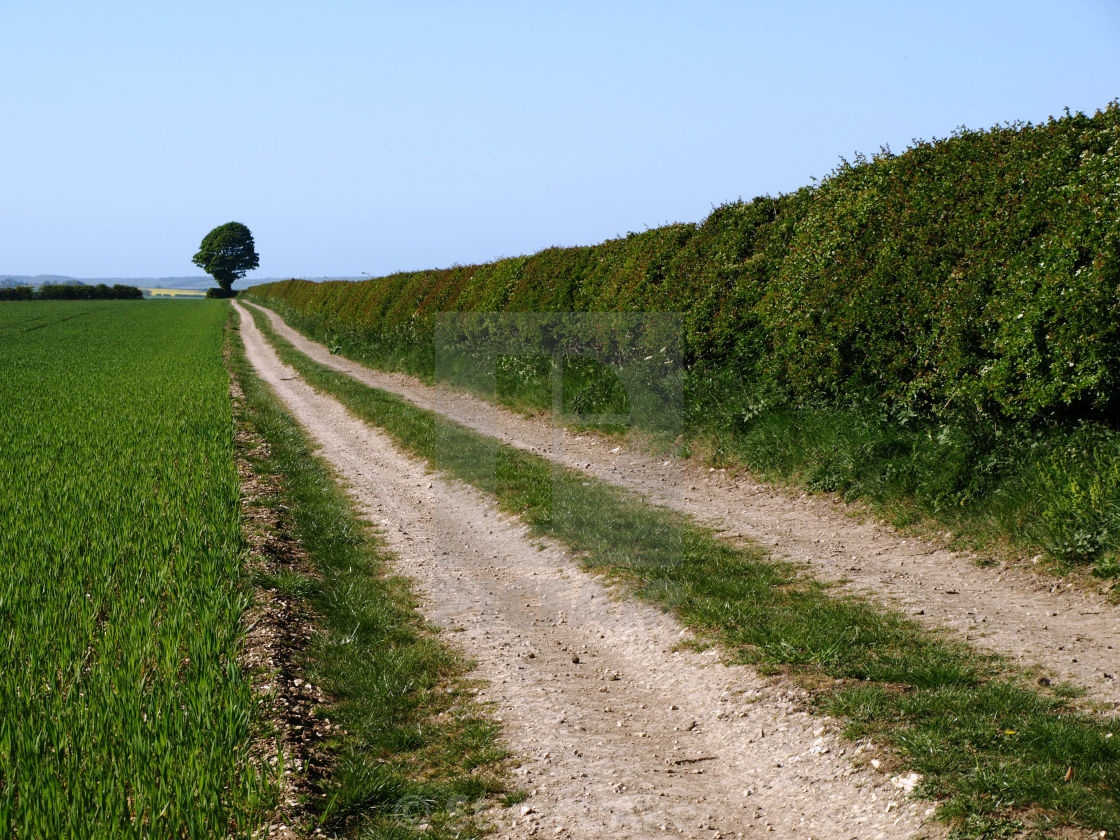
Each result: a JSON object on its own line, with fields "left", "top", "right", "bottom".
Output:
{"left": 233, "top": 306, "right": 506, "bottom": 840}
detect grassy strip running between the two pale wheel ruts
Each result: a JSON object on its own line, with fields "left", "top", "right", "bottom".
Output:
{"left": 253, "top": 300, "right": 1120, "bottom": 838}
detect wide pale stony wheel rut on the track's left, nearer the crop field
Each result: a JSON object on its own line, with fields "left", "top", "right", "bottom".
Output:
{"left": 235, "top": 305, "right": 941, "bottom": 840}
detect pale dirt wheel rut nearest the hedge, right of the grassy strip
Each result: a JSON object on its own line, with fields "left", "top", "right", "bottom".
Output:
{"left": 247, "top": 308, "right": 1120, "bottom": 715}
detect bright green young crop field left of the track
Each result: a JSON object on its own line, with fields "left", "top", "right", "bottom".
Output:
{"left": 0, "top": 301, "right": 268, "bottom": 837}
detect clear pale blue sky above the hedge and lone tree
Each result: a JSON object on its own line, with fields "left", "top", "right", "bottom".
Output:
{"left": 0, "top": 0, "right": 1120, "bottom": 279}
